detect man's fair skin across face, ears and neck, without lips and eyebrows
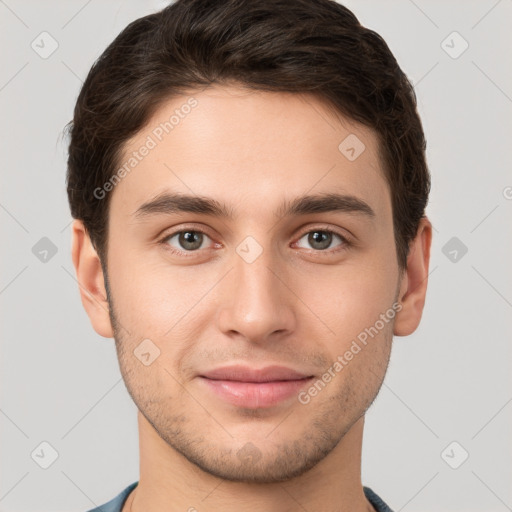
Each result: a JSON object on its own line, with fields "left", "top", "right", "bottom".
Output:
{"left": 72, "top": 85, "right": 432, "bottom": 512}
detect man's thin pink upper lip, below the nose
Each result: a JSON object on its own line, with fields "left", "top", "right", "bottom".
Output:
{"left": 200, "top": 365, "right": 312, "bottom": 382}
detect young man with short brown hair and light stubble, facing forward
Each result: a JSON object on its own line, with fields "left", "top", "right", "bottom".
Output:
{"left": 68, "top": 0, "right": 432, "bottom": 512}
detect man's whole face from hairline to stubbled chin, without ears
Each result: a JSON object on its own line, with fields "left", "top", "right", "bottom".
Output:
{"left": 103, "top": 87, "right": 400, "bottom": 482}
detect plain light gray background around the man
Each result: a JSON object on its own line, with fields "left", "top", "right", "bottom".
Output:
{"left": 0, "top": 0, "right": 512, "bottom": 512}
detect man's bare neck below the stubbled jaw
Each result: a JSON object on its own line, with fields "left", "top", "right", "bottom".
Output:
{"left": 127, "top": 412, "right": 374, "bottom": 512}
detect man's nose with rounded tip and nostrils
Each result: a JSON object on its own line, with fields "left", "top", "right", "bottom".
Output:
{"left": 217, "top": 243, "right": 298, "bottom": 344}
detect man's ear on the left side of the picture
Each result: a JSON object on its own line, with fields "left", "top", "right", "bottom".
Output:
{"left": 71, "top": 220, "right": 114, "bottom": 338}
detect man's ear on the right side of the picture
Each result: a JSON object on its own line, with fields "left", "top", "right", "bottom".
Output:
{"left": 394, "top": 217, "right": 432, "bottom": 336}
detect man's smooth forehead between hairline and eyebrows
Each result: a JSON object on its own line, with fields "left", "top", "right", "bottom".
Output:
{"left": 107, "top": 86, "right": 391, "bottom": 220}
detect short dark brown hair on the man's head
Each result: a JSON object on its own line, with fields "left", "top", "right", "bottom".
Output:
{"left": 67, "top": 0, "right": 430, "bottom": 270}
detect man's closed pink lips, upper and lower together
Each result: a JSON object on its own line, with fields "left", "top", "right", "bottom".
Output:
{"left": 199, "top": 366, "right": 313, "bottom": 409}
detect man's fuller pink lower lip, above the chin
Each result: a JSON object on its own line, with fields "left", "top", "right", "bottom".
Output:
{"left": 200, "top": 377, "right": 313, "bottom": 409}
